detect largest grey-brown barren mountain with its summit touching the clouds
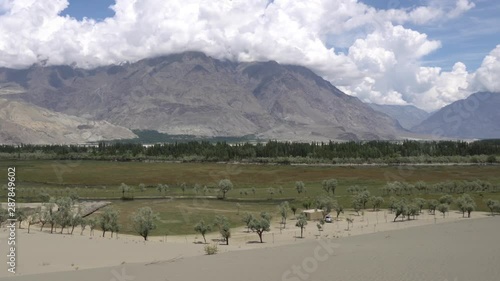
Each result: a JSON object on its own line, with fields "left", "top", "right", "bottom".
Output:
{"left": 0, "top": 52, "right": 404, "bottom": 141}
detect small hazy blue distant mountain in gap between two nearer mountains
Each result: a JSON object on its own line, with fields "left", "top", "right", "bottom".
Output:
{"left": 368, "top": 103, "right": 430, "bottom": 130}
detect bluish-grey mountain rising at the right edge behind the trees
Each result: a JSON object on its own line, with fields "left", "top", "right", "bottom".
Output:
{"left": 412, "top": 92, "right": 500, "bottom": 139}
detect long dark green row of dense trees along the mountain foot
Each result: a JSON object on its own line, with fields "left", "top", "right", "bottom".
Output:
{"left": 0, "top": 140, "right": 500, "bottom": 163}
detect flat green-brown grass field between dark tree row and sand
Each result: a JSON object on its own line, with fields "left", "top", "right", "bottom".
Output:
{"left": 0, "top": 160, "right": 500, "bottom": 235}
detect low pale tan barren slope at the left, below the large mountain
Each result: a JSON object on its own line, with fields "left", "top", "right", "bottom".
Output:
{"left": 0, "top": 98, "right": 136, "bottom": 144}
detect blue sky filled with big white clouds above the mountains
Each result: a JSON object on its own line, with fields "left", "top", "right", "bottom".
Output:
{"left": 0, "top": 0, "right": 500, "bottom": 111}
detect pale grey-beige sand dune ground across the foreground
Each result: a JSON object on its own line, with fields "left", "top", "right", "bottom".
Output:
{"left": 0, "top": 211, "right": 500, "bottom": 281}
